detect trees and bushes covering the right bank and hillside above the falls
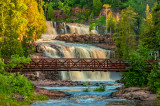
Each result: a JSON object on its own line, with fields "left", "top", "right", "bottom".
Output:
{"left": 44, "top": 0, "right": 160, "bottom": 99}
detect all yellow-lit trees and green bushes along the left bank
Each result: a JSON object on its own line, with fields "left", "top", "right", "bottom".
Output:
{"left": 0, "top": 0, "right": 48, "bottom": 106}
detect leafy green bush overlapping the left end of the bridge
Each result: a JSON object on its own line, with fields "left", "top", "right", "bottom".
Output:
{"left": 5, "top": 55, "right": 31, "bottom": 70}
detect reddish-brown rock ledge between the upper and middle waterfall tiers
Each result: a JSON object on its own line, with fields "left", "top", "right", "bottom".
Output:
{"left": 55, "top": 34, "right": 115, "bottom": 49}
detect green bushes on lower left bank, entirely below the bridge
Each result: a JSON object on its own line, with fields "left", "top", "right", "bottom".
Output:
{"left": 0, "top": 71, "right": 48, "bottom": 106}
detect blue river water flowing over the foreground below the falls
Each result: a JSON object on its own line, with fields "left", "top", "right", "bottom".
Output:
{"left": 30, "top": 81, "right": 154, "bottom": 106}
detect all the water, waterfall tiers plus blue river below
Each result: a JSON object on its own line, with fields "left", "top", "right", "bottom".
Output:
{"left": 30, "top": 22, "right": 158, "bottom": 106}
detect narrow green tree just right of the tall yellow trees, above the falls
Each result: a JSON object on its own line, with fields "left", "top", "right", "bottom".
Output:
{"left": 47, "top": 2, "right": 54, "bottom": 21}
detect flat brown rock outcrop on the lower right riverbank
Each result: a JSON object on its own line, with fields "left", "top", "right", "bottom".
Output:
{"left": 113, "top": 87, "right": 156, "bottom": 101}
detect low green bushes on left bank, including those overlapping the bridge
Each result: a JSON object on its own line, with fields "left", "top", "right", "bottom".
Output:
{"left": 0, "top": 55, "right": 48, "bottom": 106}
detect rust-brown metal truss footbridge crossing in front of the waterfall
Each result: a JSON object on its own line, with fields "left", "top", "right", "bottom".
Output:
{"left": 5, "top": 58, "right": 153, "bottom": 72}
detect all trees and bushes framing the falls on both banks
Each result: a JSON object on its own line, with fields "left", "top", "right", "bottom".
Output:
{"left": 0, "top": 0, "right": 160, "bottom": 105}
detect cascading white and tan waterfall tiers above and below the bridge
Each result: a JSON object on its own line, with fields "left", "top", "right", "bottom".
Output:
{"left": 37, "top": 22, "right": 121, "bottom": 81}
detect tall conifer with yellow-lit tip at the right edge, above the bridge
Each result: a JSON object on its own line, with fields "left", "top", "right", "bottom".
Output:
{"left": 140, "top": 3, "right": 160, "bottom": 50}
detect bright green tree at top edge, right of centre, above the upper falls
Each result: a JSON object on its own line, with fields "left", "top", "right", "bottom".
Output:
{"left": 93, "top": 0, "right": 103, "bottom": 16}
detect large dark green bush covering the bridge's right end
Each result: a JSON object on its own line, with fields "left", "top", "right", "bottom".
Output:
{"left": 121, "top": 52, "right": 148, "bottom": 87}
